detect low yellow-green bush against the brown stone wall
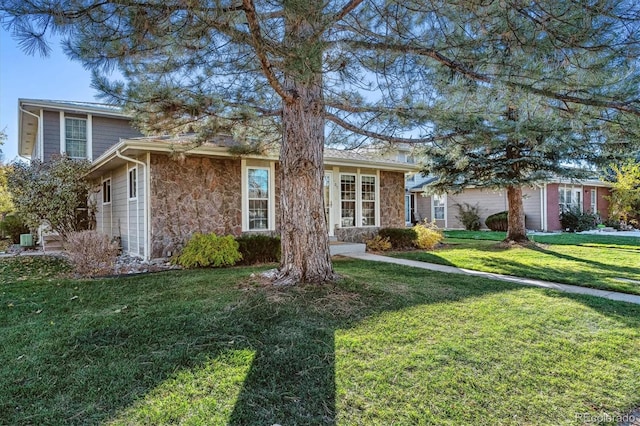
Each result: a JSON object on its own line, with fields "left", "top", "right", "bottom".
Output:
{"left": 174, "top": 233, "right": 242, "bottom": 268}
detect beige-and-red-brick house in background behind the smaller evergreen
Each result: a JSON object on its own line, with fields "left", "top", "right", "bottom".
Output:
{"left": 405, "top": 178, "right": 611, "bottom": 231}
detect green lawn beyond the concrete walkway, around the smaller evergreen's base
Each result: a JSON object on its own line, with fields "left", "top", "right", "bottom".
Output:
{"left": 391, "top": 231, "right": 640, "bottom": 294}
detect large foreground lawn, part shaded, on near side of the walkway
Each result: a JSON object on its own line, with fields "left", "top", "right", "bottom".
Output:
{"left": 0, "top": 255, "right": 640, "bottom": 425}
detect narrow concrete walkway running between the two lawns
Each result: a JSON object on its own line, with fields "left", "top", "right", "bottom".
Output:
{"left": 341, "top": 253, "right": 640, "bottom": 305}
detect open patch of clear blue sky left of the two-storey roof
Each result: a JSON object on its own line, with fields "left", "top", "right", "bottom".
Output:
{"left": 0, "top": 29, "right": 97, "bottom": 163}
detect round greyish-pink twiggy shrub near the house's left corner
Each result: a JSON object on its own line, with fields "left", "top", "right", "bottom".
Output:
{"left": 64, "top": 231, "right": 120, "bottom": 276}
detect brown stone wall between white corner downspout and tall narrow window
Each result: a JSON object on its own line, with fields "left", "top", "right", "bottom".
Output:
{"left": 150, "top": 155, "right": 242, "bottom": 257}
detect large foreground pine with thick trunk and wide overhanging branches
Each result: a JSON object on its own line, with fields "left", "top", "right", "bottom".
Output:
{"left": 5, "top": 0, "right": 640, "bottom": 283}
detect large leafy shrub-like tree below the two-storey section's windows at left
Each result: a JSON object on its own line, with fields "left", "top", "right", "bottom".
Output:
{"left": 8, "top": 155, "right": 93, "bottom": 240}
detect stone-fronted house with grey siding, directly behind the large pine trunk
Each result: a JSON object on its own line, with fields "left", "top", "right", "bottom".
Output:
{"left": 19, "top": 100, "right": 415, "bottom": 258}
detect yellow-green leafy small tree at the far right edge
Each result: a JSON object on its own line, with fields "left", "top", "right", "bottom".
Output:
{"left": 609, "top": 160, "right": 640, "bottom": 226}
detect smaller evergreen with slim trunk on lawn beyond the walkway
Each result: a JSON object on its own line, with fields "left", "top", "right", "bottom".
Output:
{"left": 404, "top": 2, "right": 640, "bottom": 242}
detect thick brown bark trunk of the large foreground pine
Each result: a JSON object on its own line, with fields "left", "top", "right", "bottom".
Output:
{"left": 276, "top": 3, "right": 336, "bottom": 285}
